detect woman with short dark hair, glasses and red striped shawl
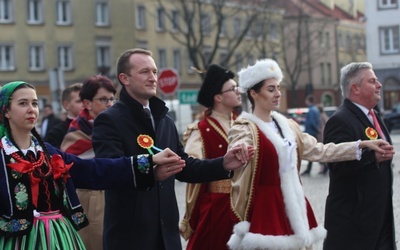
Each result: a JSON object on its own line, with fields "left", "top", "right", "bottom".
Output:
{"left": 61, "top": 75, "right": 116, "bottom": 250}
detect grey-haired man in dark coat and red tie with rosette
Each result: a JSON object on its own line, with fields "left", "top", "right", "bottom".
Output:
{"left": 324, "top": 62, "right": 396, "bottom": 250}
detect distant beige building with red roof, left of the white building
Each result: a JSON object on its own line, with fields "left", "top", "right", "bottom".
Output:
{"left": 277, "top": 0, "right": 366, "bottom": 108}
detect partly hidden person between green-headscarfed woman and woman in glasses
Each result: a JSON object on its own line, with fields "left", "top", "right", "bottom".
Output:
{"left": 44, "top": 83, "right": 82, "bottom": 148}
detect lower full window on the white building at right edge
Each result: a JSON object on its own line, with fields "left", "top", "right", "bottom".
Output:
{"left": 379, "top": 26, "right": 400, "bottom": 54}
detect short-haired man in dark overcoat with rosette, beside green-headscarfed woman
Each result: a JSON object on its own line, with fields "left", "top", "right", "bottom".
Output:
{"left": 92, "top": 49, "right": 254, "bottom": 250}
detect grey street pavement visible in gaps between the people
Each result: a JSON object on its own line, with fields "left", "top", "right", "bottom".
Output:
{"left": 175, "top": 130, "right": 400, "bottom": 250}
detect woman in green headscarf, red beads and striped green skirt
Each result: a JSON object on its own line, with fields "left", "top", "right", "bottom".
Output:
{"left": 0, "top": 81, "right": 184, "bottom": 250}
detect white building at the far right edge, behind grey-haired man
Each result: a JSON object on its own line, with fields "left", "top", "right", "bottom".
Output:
{"left": 365, "top": 0, "right": 400, "bottom": 110}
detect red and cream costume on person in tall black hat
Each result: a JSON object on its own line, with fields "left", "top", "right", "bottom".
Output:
{"left": 180, "top": 111, "right": 235, "bottom": 250}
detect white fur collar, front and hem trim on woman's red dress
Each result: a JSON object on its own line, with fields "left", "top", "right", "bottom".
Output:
{"left": 228, "top": 111, "right": 326, "bottom": 249}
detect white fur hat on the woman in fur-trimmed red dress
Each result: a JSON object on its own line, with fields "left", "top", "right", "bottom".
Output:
{"left": 238, "top": 59, "right": 283, "bottom": 93}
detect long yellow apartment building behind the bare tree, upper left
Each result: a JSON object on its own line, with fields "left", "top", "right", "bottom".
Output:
{"left": 0, "top": 0, "right": 282, "bottom": 113}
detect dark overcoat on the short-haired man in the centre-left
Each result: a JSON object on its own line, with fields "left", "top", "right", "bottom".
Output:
{"left": 92, "top": 88, "right": 228, "bottom": 250}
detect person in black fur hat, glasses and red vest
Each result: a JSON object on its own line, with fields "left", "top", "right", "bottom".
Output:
{"left": 180, "top": 64, "right": 241, "bottom": 249}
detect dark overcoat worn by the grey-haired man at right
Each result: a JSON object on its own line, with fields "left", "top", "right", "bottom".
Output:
{"left": 324, "top": 99, "right": 396, "bottom": 250}
